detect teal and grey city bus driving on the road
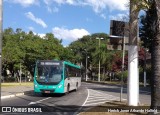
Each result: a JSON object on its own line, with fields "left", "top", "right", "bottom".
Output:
{"left": 34, "top": 60, "right": 81, "bottom": 94}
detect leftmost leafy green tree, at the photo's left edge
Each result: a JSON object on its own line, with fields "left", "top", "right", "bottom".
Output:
{"left": 2, "top": 28, "right": 23, "bottom": 76}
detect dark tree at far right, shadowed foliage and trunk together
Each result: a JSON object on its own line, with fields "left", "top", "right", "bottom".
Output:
{"left": 140, "top": 0, "right": 160, "bottom": 109}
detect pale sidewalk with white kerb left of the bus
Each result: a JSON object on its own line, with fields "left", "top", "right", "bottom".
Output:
{"left": 1, "top": 85, "right": 33, "bottom": 99}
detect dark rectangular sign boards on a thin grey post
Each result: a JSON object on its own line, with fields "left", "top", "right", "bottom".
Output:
{"left": 107, "top": 20, "right": 129, "bottom": 101}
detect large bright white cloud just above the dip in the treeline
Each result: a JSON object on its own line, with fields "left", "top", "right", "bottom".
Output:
{"left": 52, "top": 27, "right": 90, "bottom": 42}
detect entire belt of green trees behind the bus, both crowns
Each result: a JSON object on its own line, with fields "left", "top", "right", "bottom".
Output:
{"left": 2, "top": 28, "right": 126, "bottom": 81}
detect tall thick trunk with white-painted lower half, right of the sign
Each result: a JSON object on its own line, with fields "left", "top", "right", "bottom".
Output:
{"left": 127, "top": 0, "right": 139, "bottom": 106}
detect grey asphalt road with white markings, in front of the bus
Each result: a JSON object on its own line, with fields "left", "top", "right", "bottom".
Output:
{"left": 1, "top": 82, "right": 150, "bottom": 115}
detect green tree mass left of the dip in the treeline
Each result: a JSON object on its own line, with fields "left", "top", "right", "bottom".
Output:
{"left": 2, "top": 28, "right": 67, "bottom": 76}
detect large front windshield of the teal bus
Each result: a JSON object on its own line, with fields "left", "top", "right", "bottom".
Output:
{"left": 36, "top": 65, "right": 62, "bottom": 84}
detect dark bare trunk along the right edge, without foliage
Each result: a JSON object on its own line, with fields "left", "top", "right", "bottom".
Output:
{"left": 151, "top": 0, "right": 160, "bottom": 109}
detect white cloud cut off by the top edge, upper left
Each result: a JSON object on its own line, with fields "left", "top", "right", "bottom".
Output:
{"left": 5, "top": 0, "right": 39, "bottom": 7}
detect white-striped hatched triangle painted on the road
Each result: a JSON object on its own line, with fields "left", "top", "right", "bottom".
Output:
{"left": 83, "top": 89, "right": 119, "bottom": 106}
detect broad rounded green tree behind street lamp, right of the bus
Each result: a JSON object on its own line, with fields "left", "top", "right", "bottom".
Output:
{"left": 69, "top": 33, "right": 109, "bottom": 67}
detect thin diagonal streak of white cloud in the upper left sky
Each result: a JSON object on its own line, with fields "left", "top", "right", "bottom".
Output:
{"left": 25, "top": 12, "right": 47, "bottom": 28}
